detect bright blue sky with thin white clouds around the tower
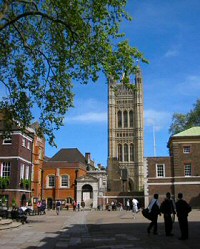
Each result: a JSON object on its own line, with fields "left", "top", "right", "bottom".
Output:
{"left": 46, "top": 0, "right": 200, "bottom": 166}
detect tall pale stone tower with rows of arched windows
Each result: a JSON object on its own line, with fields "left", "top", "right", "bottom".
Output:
{"left": 108, "top": 69, "right": 144, "bottom": 192}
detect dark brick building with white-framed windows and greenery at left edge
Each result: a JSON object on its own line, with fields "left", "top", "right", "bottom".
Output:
{"left": 0, "top": 114, "right": 34, "bottom": 207}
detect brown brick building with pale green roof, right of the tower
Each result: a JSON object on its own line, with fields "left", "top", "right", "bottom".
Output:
{"left": 145, "top": 127, "right": 200, "bottom": 208}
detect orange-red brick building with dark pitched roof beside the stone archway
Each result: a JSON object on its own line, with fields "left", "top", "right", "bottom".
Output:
{"left": 41, "top": 148, "right": 88, "bottom": 208}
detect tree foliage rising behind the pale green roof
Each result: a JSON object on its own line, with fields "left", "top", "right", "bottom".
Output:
{"left": 169, "top": 99, "right": 200, "bottom": 135}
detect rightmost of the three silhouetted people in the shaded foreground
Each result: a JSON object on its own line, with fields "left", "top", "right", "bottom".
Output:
{"left": 176, "top": 193, "right": 192, "bottom": 240}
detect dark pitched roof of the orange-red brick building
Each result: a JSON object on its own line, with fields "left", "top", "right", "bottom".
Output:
{"left": 48, "top": 148, "right": 86, "bottom": 164}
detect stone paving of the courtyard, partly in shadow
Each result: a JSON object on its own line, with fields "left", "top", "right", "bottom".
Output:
{"left": 0, "top": 210, "right": 200, "bottom": 249}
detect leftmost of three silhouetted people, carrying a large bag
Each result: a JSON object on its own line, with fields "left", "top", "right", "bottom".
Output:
{"left": 147, "top": 194, "right": 160, "bottom": 234}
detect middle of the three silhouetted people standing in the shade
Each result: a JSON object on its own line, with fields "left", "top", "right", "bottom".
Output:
{"left": 160, "top": 192, "right": 176, "bottom": 236}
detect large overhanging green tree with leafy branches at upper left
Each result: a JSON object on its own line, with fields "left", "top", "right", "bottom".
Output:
{"left": 0, "top": 0, "right": 146, "bottom": 145}
